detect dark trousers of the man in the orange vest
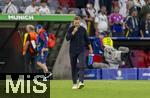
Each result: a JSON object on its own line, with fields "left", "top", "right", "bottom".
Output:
{"left": 25, "top": 52, "right": 36, "bottom": 73}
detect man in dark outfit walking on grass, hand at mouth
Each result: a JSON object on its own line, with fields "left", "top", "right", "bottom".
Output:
{"left": 66, "top": 16, "right": 93, "bottom": 89}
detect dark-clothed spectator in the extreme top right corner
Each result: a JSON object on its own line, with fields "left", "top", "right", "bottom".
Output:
{"left": 140, "top": 0, "right": 150, "bottom": 19}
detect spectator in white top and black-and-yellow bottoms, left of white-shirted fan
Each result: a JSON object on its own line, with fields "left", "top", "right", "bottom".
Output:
{"left": 83, "top": 3, "right": 95, "bottom": 36}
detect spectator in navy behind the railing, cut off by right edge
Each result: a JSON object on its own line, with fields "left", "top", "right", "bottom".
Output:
{"left": 140, "top": 13, "right": 150, "bottom": 37}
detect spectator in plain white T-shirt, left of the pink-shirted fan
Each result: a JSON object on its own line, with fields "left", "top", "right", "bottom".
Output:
{"left": 95, "top": 6, "right": 108, "bottom": 36}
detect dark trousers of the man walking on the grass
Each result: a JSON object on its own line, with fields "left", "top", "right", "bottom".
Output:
{"left": 70, "top": 51, "right": 85, "bottom": 84}
